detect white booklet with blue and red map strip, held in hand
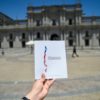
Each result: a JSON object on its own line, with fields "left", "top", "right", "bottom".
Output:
{"left": 34, "top": 41, "right": 68, "bottom": 79}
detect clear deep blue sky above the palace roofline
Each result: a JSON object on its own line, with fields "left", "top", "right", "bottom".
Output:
{"left": 0, "top": 0, "right": 100, "bottom": 19}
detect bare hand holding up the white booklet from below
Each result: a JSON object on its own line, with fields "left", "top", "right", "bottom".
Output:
{"left": 26, "top": 74, "right": 54, "bottom": 100}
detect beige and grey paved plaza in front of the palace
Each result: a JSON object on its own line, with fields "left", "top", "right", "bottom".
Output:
{"left": 0, "top": 48, "right": 100, "bottom": 100}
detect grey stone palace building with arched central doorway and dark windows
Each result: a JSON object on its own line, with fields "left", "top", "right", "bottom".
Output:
{"left": 0, "top": 3, "right": 100, "bottom": 49}
